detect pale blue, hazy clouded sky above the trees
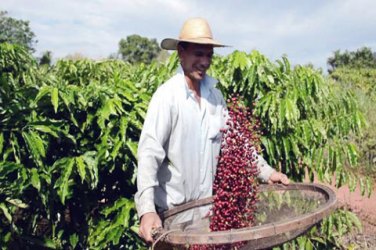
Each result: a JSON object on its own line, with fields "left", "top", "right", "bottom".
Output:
{"left": 0, "top": 0, "right": 376, "bottom": 70}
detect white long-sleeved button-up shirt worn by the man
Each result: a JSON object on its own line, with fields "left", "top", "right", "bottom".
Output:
{"left": 135, "top": 70, "right": 274, "bottom": 217}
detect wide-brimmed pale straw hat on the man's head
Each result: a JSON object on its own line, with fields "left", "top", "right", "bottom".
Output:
{"left": 161, "top": 18, "right": 227, "bottom": 50}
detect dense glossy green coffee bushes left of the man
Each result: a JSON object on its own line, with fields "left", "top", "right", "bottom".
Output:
{"left": 0, "top": 44, "right": 159, "bottom": 249}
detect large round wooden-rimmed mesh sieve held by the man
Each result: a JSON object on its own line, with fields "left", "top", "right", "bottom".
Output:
{"left": 155, "top": 184, "right": 336, "bottom": 249}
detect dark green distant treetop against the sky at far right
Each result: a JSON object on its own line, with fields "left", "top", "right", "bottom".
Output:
{"left": 327, "top": 47, "right": 376, "bottom": 73}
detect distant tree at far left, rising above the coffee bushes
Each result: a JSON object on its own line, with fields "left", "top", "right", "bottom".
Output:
{"left": 0, "top": 11, "right": 37, "bottom": 52}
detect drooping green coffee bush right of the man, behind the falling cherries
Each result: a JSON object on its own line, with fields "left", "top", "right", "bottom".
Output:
{"left": 212, "top": 51, "right": 365, "bottom": 193}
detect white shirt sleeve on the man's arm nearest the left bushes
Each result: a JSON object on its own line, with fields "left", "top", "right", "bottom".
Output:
{"left": 135, "top": 89, "right": 171, "bottom": 217}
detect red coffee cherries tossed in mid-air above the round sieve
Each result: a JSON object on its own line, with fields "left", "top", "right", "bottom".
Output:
{"left": 191, "top": 97, "right": 260, "bottom": 249}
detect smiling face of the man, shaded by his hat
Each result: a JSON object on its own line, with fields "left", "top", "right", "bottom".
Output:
{"left": 178, "top": 43, "right": 213, "bottom": 83}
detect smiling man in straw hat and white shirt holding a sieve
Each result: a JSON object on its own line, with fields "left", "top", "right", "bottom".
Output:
{"left": 135, "top": 18, "right": 289, "bottom": 242}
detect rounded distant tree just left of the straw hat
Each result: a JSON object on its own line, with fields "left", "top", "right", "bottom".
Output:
{"left": 118, "top": 35, "right": 161, "bottom": 64}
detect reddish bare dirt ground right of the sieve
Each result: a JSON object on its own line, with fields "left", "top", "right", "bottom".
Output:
{"left": 308, "top": 176, "right": 376, "bottom": 250}
